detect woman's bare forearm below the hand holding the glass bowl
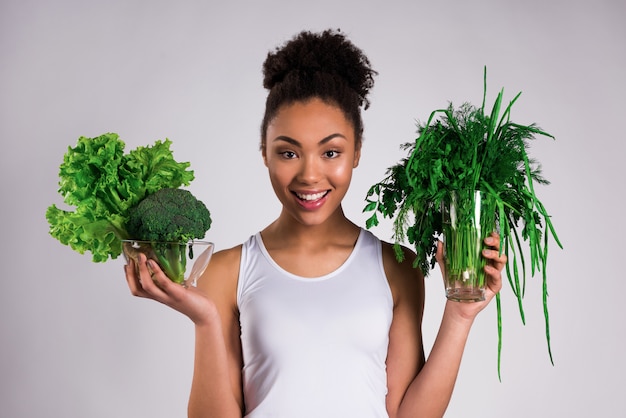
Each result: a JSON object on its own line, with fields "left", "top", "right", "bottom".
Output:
{"left": 188, "top": 321, "right": 242, "bottom": 418}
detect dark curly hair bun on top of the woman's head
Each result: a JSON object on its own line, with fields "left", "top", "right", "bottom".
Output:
{"left": 263, "top": 29, "right": 376, "bottom": 107}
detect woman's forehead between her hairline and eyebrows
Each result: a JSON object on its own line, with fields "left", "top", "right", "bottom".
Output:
{"left": 267, "top": 98, "right": 354, "bottom": 141}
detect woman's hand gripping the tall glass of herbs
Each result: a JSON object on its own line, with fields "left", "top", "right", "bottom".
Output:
{"left": 436, "top": 232, "right": 507, "bottom": 319}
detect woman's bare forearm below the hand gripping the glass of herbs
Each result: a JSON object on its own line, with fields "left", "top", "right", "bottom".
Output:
{"left": 398, "top": 301, "right": 473, "bottom": 418}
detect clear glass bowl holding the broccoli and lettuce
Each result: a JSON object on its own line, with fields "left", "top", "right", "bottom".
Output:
{"left": 122, "top": 239, "right": 215, "bottom": 287}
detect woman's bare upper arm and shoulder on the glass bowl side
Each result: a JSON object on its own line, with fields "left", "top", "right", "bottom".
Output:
{"left": 196, "top": 245, "right": 243, "bottom": 407}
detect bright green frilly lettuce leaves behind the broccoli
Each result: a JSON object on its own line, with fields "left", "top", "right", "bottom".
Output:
{"left": 46, "top": 133, "right": 194, "bottom": 263}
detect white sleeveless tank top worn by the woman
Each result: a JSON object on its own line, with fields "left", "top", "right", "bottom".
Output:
{"left": 237, "top": 229, "right": 393, "bottom": 418}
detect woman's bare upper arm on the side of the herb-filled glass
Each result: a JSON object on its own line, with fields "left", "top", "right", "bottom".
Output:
{"left": 383, "top": 243, "right": 425, "bottom": 417}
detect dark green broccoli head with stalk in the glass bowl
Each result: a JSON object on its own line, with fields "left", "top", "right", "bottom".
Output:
{"left": 126, "top": 188, "right": 211, "bottom": 283}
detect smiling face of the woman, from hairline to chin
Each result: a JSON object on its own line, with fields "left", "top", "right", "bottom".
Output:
{"left": 263, "top": 99, "right": 360, "bottom": 225}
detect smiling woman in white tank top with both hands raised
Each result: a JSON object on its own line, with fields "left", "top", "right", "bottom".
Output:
{"left": 126, "top": 31, "right": 506, "bottom": 418}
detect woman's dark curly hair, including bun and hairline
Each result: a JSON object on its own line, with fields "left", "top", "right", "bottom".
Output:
{"left": 261, "top": 29, "right": 377, "bottom": 149}
